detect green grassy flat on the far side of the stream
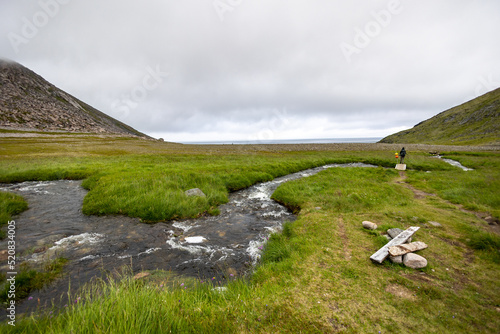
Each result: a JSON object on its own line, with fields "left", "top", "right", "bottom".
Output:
{"left": 0, "top": 137, "right": 453, "bottom": 222}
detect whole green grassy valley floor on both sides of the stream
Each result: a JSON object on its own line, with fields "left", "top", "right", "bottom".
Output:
{"left": 0, "top": 136, "right": 500, "bottom": 333}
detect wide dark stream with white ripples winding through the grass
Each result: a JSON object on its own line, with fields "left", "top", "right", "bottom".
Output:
{"left": 0, "top": 163, "right": 376, "bottom": 312}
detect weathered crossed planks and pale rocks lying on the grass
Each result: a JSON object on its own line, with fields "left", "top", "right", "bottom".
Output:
{"left": 362, "top": 221, "right": 428, "bottom": 269}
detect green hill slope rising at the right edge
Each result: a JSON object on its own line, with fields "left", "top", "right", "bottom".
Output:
{"left": 380, "top": 88, "right": 500, "bottom": 145}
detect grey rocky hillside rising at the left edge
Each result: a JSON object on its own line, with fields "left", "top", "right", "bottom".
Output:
{"left": 0, "top": 59, "right": 148, "bottom": 137}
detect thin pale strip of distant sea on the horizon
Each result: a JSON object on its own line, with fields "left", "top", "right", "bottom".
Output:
{"left": 180, "top": 137, "right": 383, "bottom": 145}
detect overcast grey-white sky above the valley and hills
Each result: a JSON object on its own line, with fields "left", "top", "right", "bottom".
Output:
{"left": 0, "top": 0, "right": 500, "bottom": 142}
